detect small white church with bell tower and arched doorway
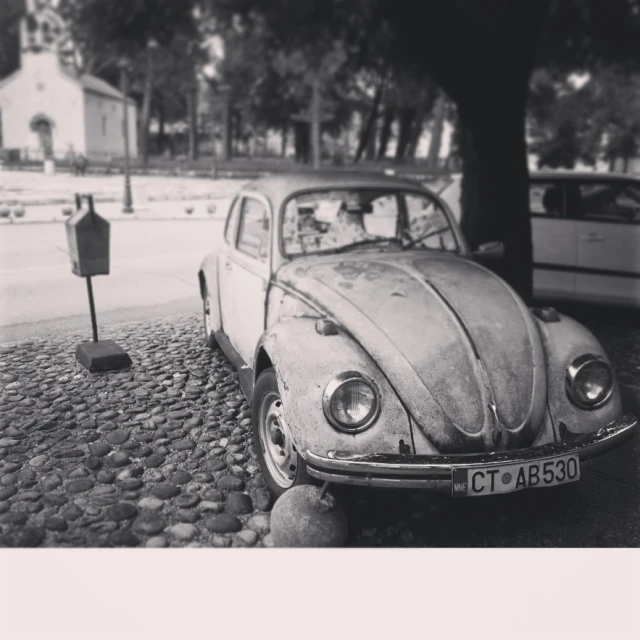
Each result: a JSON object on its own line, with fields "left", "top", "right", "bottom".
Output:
{"left": 0, "top": 0, "right": 137, "bottom": 160}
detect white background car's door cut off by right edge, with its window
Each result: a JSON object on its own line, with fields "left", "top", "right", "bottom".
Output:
{"left": 572, "top": 179, "right": 640, "bottom": 307}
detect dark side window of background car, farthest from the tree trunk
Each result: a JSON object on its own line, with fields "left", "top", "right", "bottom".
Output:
{"left": 580, "top": 181, "right": 640, "bottom": 224}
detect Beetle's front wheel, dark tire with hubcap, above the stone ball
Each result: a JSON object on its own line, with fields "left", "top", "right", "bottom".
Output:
{"left": 251, "top": 368, "right": 314, "bottom": 498}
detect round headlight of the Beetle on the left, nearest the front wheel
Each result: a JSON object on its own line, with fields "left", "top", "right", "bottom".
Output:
{"left": 322, "top": 371, "right": 380, "bottom": 433}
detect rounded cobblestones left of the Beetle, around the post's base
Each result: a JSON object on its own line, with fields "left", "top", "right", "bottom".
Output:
{"left": 0, "top": 315, "right": 271, "bottom": 548}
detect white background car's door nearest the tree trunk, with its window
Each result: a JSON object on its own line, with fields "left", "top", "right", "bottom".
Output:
{"left": 529, "top": 179, "right": 577, "bottom": 299}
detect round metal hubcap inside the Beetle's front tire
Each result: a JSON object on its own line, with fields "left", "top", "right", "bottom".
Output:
{"left": 258, "top": 391, "right": 298, "bottom": 489}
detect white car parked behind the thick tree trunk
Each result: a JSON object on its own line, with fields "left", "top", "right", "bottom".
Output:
{"left": 439, "top": 171, "right": 640, "bottom": 308}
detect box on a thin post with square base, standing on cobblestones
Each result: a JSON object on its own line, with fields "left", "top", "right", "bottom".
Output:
{"left": 65, "top": 194, "right": 131, "bottom": 371}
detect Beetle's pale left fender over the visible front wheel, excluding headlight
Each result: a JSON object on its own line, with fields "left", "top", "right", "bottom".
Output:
{"left": 253, "top": 318, "right": 413, "bottom": 457}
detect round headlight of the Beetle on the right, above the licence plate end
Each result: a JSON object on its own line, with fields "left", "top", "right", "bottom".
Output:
{"left": 566, "top": 354, "right": 614, "bottom": 409}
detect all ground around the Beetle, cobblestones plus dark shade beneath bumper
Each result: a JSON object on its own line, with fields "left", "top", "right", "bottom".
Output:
{"left": 0, "top": 308, "right": 640, "bottom": 547}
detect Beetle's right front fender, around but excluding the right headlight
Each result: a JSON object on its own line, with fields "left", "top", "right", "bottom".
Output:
{"left": 536, "top": 315, "right": 622, "bottom": 433}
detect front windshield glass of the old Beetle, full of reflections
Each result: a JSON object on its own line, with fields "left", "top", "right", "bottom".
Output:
{"left": 282, "top": 189, "right": 459, "bottom": 256}
